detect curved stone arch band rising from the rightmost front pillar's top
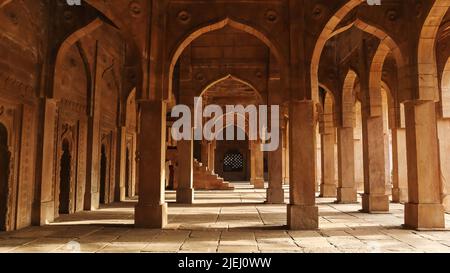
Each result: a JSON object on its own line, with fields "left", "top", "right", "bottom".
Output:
{"left": 415, "top": 0, "right": 450, "bottom": 101}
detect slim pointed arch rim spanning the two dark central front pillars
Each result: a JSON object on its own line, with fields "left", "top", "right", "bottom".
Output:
{"left": 167, "top": 18, "right": 287, "bottom": 102}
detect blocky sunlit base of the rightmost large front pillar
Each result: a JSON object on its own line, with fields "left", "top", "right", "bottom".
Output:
{"left": 405, "top": 203, "right": 445, "bottom": 229}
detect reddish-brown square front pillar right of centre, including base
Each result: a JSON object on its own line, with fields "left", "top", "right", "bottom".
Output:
{"left": 287, "top": 101, "right": 319, "bottom": 230}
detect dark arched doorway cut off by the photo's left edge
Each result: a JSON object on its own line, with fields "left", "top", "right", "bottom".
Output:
{"left": 0, "top": 123, "right": 10, "bottom": 231}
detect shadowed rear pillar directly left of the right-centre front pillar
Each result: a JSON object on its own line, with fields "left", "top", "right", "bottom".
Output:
{"left": 267, "top": 126, "right": 284, "bottom": 204}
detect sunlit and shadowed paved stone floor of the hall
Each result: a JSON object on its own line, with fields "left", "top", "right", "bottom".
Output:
{"left": 0, "top": 184, "right": 450, "bottom": 253}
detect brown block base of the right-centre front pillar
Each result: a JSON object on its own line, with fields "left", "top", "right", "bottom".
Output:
{"left": 287, "top": 205, "right": 319, "bottom": 230}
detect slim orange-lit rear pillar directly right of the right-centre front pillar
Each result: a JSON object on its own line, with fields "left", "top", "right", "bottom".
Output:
{"left": 320, "top": 125, "right": 336, "bottom": 197}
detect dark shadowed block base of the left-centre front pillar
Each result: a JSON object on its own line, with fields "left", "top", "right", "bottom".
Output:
{"left": 134, "top": 204, "right": 167, "bottom": 229}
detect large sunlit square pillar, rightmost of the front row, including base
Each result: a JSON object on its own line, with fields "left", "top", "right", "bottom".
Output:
{"left": 405, "top": 101, "right": 445, "bottom": 229}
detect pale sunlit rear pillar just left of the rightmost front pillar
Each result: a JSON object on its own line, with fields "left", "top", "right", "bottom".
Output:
{"left": 392, "top": 128, "right": 408, "bottom": 203}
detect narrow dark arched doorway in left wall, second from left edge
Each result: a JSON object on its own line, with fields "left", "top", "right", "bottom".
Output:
{"left": 59, "top": 139, "right": 72, "bottom": 214}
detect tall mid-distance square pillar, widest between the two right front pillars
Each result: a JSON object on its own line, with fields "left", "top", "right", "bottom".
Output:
{"left": 362, "top": 109, "right": 389, "bottom": 213}
